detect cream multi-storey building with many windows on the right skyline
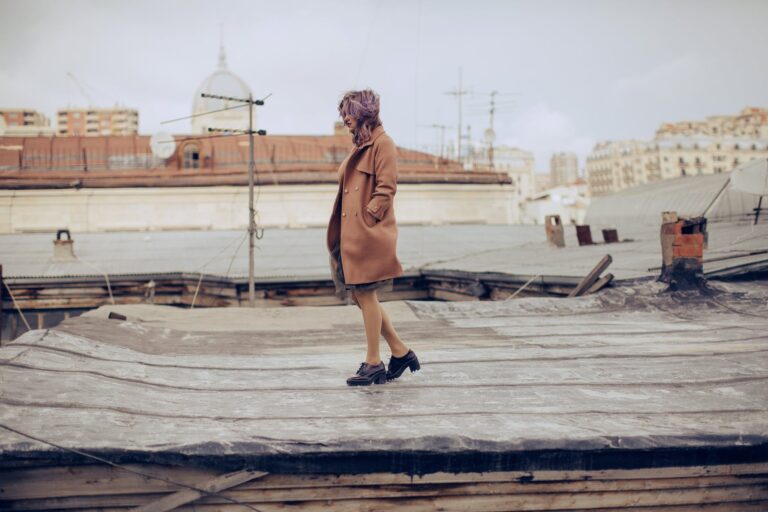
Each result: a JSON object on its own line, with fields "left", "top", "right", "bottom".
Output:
{"left": 587, "top": 107, "right": 768, "bottom": 196}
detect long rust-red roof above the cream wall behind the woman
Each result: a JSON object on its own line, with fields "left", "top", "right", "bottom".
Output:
{"left": 0, "top": 135, "right": 510, "bottom": 189}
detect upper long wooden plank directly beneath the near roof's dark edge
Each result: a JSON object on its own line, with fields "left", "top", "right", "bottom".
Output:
{"left": 0, "top": 463, "right": 768, "bottom": 503}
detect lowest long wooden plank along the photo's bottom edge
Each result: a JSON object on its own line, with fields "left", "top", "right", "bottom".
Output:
{"left": 6, "top": 476, "right": 768, "bottom": 510}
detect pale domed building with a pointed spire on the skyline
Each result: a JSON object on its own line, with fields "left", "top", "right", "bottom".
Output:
{"left": 192, "top": 46, "right": 257, "bottom": 134}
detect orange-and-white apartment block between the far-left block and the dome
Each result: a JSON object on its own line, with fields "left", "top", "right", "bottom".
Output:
{"left": 56, "top": 107, "right": 139, "bottom": 137}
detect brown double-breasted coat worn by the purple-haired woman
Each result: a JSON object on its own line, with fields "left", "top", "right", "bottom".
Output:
{"left": 327, "top": 126, "right": 403, "bottom": 284}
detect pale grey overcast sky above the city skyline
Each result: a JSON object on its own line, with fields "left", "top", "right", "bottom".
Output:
{"left": 0, "top": 0, "right": 768, "bottom": 171}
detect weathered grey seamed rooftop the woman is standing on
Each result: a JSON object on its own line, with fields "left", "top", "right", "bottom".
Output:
{"left": 0, "top": 283, "right": 768, "bottom": 473}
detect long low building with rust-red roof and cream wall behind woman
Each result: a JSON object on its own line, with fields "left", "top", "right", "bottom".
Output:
{"left": 0, "top": 130, "right": 520, "bottom": 233}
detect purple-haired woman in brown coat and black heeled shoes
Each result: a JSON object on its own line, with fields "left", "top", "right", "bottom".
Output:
{"left": 327, "top": 89, "right": 419, "bottom": 386}
